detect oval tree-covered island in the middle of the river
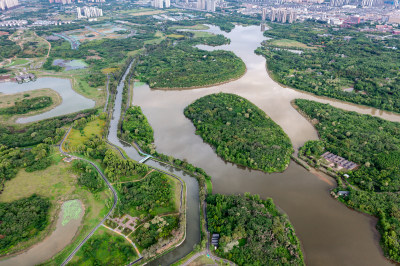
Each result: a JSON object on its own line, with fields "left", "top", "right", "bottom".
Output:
{"left": 184, "top": 93, "right": 293, "bottom": 172}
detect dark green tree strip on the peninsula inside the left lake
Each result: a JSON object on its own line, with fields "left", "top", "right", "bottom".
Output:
{"left": 0, "top": 96, "right": 53, "bottom": 115}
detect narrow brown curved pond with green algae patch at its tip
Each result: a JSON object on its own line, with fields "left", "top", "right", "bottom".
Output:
{"left": 0, "top": 200, "right": 84, "bottom": 266}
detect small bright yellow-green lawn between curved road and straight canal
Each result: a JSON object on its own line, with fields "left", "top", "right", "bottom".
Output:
{"left": 64, "top": 118, "right": 106, "bottom": 151}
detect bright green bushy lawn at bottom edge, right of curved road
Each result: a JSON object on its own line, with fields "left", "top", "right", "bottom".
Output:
{"left": 70, "top": 227, "right": 138, "bottom": 265}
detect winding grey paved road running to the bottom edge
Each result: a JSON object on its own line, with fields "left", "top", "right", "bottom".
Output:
{"left": 59, "top": 127, "right": 118, "bottom": 266}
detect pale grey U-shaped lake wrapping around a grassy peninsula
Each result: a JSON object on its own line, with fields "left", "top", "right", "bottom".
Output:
{"left": 0, "top": 77, "right": 95, "bottom": 124}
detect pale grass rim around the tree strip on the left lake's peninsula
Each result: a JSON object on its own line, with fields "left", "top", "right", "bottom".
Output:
{"left": 0, "top": 89, "right": 62, "bottom": 124}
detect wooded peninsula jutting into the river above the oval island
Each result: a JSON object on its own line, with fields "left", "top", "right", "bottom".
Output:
{"left": 135, "top": 40, "right": 246, "bottom": 88}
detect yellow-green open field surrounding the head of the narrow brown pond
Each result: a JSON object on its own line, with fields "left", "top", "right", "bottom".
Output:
{"left": 0, "top": 151, "right": 109, "bottom": 258}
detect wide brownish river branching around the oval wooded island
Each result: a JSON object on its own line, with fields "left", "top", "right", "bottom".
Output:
{"left": 133, "top": 26, "right": 400, "bottom": 266}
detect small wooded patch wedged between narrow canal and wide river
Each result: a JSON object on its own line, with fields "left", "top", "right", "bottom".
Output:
{"left": 122, "top": 106, "right": 154, "bottom": 150}
